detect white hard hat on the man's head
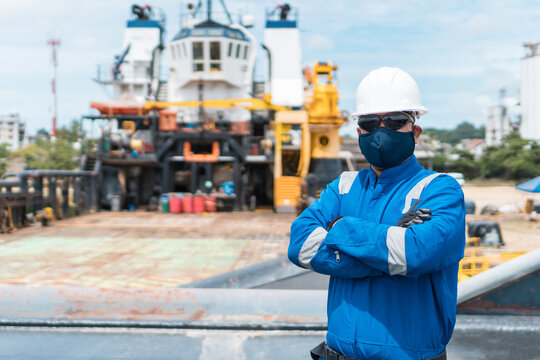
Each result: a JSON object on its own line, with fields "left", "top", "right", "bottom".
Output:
{"left": 351, "top": 67, "right": 427, "bottom": 120}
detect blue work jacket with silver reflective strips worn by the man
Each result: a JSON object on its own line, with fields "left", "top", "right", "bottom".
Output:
{"left": 288, "top": 156, "right": 465, "bottom": 359}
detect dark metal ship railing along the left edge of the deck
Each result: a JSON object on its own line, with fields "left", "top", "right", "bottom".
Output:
{"left": 0, "top": 168, "right": 99, "bottom": 231}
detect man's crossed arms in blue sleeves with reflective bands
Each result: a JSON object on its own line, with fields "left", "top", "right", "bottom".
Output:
{"left": 288, "top": 176, "right": 465, "bottom": 278}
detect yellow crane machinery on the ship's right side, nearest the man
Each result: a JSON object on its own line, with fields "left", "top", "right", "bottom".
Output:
{"left": 274, "top": 62, "right": 343, "bottom": 212}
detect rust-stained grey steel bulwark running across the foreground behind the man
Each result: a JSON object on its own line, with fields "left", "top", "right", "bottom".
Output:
{"left": 0, "top": 250, "right": 540, "bottom": 360}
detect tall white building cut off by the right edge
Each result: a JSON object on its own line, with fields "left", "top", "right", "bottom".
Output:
{"left": 519, "top": 43, "right": 540, "bottom": 140}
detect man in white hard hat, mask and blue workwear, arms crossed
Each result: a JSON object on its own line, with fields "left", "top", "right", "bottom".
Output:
{"left": 288, "top": 67, "right": 465, "bottom": 360}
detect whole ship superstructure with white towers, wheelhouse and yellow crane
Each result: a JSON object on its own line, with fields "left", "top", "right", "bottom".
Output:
{"left": 85, "top": 0, "right": 343, "bottom": 212}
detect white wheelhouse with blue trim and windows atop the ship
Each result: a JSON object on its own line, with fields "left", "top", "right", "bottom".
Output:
{"left": 168, "top": 1, "right": 257, "bottom": 123}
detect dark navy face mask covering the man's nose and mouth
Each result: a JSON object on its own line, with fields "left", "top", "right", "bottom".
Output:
{"left": 358, "top": 127, "right": 414, "bottom": 169}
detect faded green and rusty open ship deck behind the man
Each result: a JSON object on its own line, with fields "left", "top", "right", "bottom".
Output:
{"left": 0, "top": 212, "right": 292, "bottom": 288}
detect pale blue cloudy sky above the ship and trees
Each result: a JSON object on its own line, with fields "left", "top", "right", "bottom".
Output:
{"left": 0, "top": 0, "right": 540, "bottom": 133}
